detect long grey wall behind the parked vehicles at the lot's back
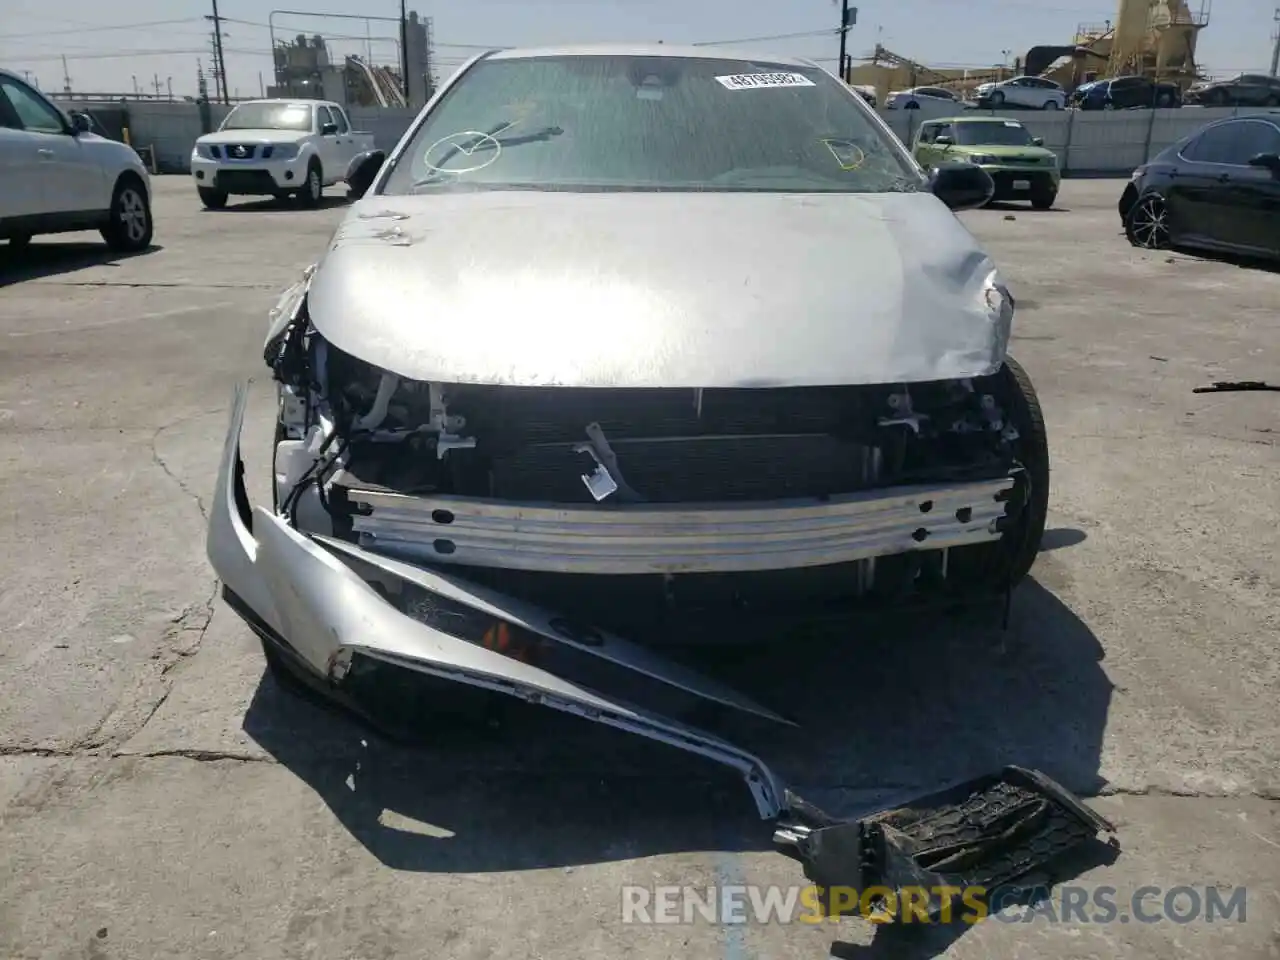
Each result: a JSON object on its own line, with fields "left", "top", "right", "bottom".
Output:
{"left": 67, "top": 101, "right": 1280, "bottom": 177}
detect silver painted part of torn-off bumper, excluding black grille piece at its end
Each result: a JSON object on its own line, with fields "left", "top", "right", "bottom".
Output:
{"left": 207, "top": 384, "right": 786, "bottom": 819}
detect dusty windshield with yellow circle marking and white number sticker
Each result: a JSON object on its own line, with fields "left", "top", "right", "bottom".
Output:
{"left": 381, "top": 55, "right": 923, "bottom": 195}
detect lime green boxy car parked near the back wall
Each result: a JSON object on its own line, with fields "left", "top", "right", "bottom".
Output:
{"left": 911, "top": 116, "right": 1062, "bottom": 210}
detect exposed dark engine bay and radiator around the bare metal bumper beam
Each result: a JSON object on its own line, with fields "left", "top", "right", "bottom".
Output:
{"left": 265, "top": 303, "right": 1021, "bottom": 635}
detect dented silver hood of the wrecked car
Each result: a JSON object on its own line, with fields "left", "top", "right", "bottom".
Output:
{"left": 308, "top": 191, "right": 1011, "bottom": 388}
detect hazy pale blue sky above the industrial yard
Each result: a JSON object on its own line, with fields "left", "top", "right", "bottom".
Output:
{"left": 0, "top": 0, "right": 1276, "bottom": 96}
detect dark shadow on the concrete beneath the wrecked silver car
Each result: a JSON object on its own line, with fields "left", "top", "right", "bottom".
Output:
{"left": 243, "top": 570, "right": 1111, "bottom": 911}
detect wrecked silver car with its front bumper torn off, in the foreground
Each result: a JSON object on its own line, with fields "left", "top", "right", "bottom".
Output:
{"left": 209, "top": 46, "right": 1111, "bottom": 906}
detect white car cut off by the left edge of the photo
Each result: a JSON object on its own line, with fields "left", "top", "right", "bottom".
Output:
{"left": 0, "top": 70, "right": 152, "bottom": 251}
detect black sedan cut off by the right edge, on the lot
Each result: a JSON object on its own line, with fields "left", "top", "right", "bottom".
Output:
{"left": 1119, "top": 110, "right": 1280, "bottom": 260}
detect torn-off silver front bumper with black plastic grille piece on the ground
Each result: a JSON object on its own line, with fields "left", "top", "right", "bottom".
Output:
{"left": 207, "top": 385, "right": 1111, "bottom": 901}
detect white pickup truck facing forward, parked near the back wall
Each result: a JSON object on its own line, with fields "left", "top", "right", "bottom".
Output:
{"left": 191, "top": 100, "right": 374, "bottom": 210}
